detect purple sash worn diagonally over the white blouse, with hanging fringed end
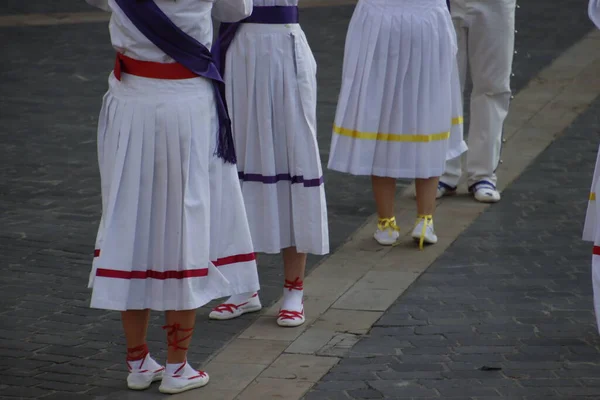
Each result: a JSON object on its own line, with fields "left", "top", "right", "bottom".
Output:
{"left": 116, "top": 0, "right": 236, "bottom": 164}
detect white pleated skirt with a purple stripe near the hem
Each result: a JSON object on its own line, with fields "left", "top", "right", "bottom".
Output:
{"left": 225, "top": 24, "right": 329, "bottom": 254}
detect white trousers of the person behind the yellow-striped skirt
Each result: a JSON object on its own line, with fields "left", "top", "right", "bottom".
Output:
{"left": 440, "top": 0, "right": 516, "bottom": 187}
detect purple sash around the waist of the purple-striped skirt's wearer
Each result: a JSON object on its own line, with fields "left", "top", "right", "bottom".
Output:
{"left": 211, "top": 6, "right": 300, "bottom": 76}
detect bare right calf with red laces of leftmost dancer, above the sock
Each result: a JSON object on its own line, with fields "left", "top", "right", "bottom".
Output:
{"left": 164, "top": 310, "right": 196, "bottom": 364}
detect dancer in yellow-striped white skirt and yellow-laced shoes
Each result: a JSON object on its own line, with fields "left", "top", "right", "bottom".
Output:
{"left": 329, "top": 0, "right": 466, "bottom": 248}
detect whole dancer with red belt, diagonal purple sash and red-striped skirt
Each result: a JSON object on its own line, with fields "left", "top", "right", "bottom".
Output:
{"left": 88, "top": 0, "right": 259, "bottom": 393}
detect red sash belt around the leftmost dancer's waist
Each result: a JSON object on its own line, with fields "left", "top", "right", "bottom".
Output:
{"left": 114, "top": 53, "right": 198, "bottom": 80}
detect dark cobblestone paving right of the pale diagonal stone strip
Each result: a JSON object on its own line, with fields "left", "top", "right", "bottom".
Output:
{"left": 305, "top": 91, "right": 600, "bottom": 400}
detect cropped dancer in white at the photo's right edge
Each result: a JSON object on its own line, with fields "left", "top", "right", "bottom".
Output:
{"left": 583, "top": 0, "right": 600, "bottom": 332}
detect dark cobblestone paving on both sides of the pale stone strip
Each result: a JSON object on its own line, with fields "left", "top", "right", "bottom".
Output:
{"left": 0, "top": 0, "right": 600, "bottom": 400}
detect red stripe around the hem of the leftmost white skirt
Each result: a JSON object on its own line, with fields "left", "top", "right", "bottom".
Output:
{"left": 94, "top": 249, "right": 256, "bottom": 280}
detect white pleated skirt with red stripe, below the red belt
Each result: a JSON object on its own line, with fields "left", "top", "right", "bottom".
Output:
{"left": 89, "top": 74, "right": 259, "bottom": 311}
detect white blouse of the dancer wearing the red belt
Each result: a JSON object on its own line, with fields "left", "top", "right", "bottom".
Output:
{"left": 86, "top": 0, "right": 252, "bottom": 63}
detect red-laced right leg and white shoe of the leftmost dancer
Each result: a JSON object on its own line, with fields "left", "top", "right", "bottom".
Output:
{"left": 159, "top": 310, "right": 208, "bottom": 394}
